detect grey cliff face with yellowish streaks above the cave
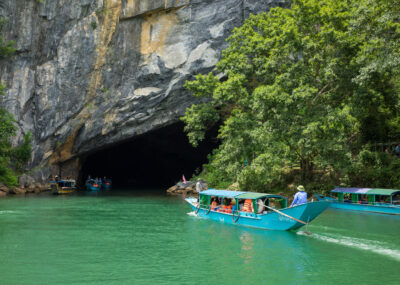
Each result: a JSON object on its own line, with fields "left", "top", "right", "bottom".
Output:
{"left": 0, "top": 0, "right": 288, "bottom": 178}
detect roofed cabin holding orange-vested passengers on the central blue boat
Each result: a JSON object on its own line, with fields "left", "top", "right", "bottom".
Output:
{"left": 199, "top": 189, "right": 287, "bottom": 216}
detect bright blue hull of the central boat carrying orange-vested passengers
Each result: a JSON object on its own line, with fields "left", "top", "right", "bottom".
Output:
{"left": 185, "top": 198, "right": 330, "bottom": 231}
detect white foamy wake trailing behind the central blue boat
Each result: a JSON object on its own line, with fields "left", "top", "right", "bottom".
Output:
{"left": 297, "top": 231, "right": 400, "bottom": 261}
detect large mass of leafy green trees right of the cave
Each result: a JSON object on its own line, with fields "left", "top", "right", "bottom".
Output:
{"left": 182, "top": 0, "right": 400, "bottom": 191}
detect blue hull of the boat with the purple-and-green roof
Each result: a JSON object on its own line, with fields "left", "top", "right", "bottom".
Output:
{"left": 314, "top": 194, "right": 400, "bottom": 215}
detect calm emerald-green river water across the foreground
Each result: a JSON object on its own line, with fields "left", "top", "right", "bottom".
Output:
{"left": 0, "top": 190, "right": 400, "bottom": 285}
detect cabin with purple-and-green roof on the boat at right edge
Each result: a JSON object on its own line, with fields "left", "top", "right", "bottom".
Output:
{"left": 331, "top": 188, "right": 400, "bottom": 206}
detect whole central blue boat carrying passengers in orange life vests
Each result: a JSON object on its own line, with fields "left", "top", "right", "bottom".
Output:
{"left": 185, "top": 189, "right": 330, "bottom": 230}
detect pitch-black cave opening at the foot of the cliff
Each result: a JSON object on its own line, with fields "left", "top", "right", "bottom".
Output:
{"left": 80, "top": 123, "right": 218, "bottom": 188}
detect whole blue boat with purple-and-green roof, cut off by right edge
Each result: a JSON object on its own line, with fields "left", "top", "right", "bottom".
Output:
{"left": 314, "top": 188, "right": 400, "bottom": 215}
